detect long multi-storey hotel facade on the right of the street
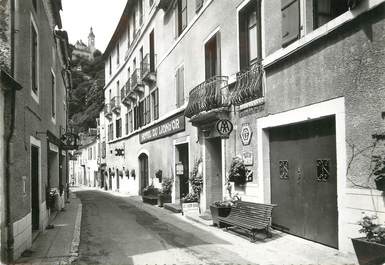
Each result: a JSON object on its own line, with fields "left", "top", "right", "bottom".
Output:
{"left": 100, "top": 0, "right": 385, "bottom": 251}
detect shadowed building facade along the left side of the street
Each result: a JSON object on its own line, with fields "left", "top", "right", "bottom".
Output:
{"left": 1, "top": 0, "right": 70, "bottom": 261}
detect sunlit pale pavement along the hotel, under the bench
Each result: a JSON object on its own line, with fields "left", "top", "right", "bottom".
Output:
{"left": 91, "top": 186, "right": 358, "bottom": 265}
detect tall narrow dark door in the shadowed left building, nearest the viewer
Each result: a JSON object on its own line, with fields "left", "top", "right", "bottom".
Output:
{"left": 31, "top": 146, "right": 40, "bottom": 230}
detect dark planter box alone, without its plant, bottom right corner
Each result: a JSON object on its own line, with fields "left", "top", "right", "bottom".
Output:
{"left": 352, "top": 237, "right": 385, "bottom": 265}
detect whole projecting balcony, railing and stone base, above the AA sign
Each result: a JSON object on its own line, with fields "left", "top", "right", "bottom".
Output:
{"left": 185, "top": 76, "right": 230, "bottom": 121}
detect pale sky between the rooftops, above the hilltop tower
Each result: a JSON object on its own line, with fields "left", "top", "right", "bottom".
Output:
{"left": 61, "top": 0, "right": 127, "bottom": 53}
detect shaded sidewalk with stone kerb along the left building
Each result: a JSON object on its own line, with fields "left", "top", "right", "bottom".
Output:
{"left": 14, "top": 192, "right": 82, "bottom": 265}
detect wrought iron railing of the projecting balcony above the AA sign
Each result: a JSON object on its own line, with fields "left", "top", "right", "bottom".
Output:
{"left": 185, "top": 76, "right": 230, "bottom": 118}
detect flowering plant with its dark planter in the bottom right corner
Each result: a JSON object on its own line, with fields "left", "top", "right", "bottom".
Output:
{"left": 352, "top": 213, "right": 385, "bottom": 265}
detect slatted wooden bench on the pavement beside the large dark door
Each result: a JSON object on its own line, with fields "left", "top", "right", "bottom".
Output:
{"left": 218, "top": 201, "right": 276, "bottom": 242}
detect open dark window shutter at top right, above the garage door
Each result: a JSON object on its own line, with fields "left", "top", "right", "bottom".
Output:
{"left": 281, "top": 0, "right": 300, "bottom": 46}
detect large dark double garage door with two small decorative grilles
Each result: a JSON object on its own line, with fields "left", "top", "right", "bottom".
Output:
{"left": 270, "top": 117, "right": 338, "bottom": 248}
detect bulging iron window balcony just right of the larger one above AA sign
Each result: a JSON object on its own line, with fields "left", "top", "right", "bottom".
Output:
{"left": 231, "top": 64, "right": 264, "bottom": 106}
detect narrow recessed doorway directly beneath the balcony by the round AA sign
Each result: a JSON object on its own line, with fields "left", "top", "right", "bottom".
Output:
{"left": 205, "top": 137, "right": 223, "bottom": 209}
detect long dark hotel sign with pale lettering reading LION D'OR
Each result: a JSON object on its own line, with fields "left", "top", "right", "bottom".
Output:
{"left": 139, "top": 112, "right": 185, "bottom": 144}
